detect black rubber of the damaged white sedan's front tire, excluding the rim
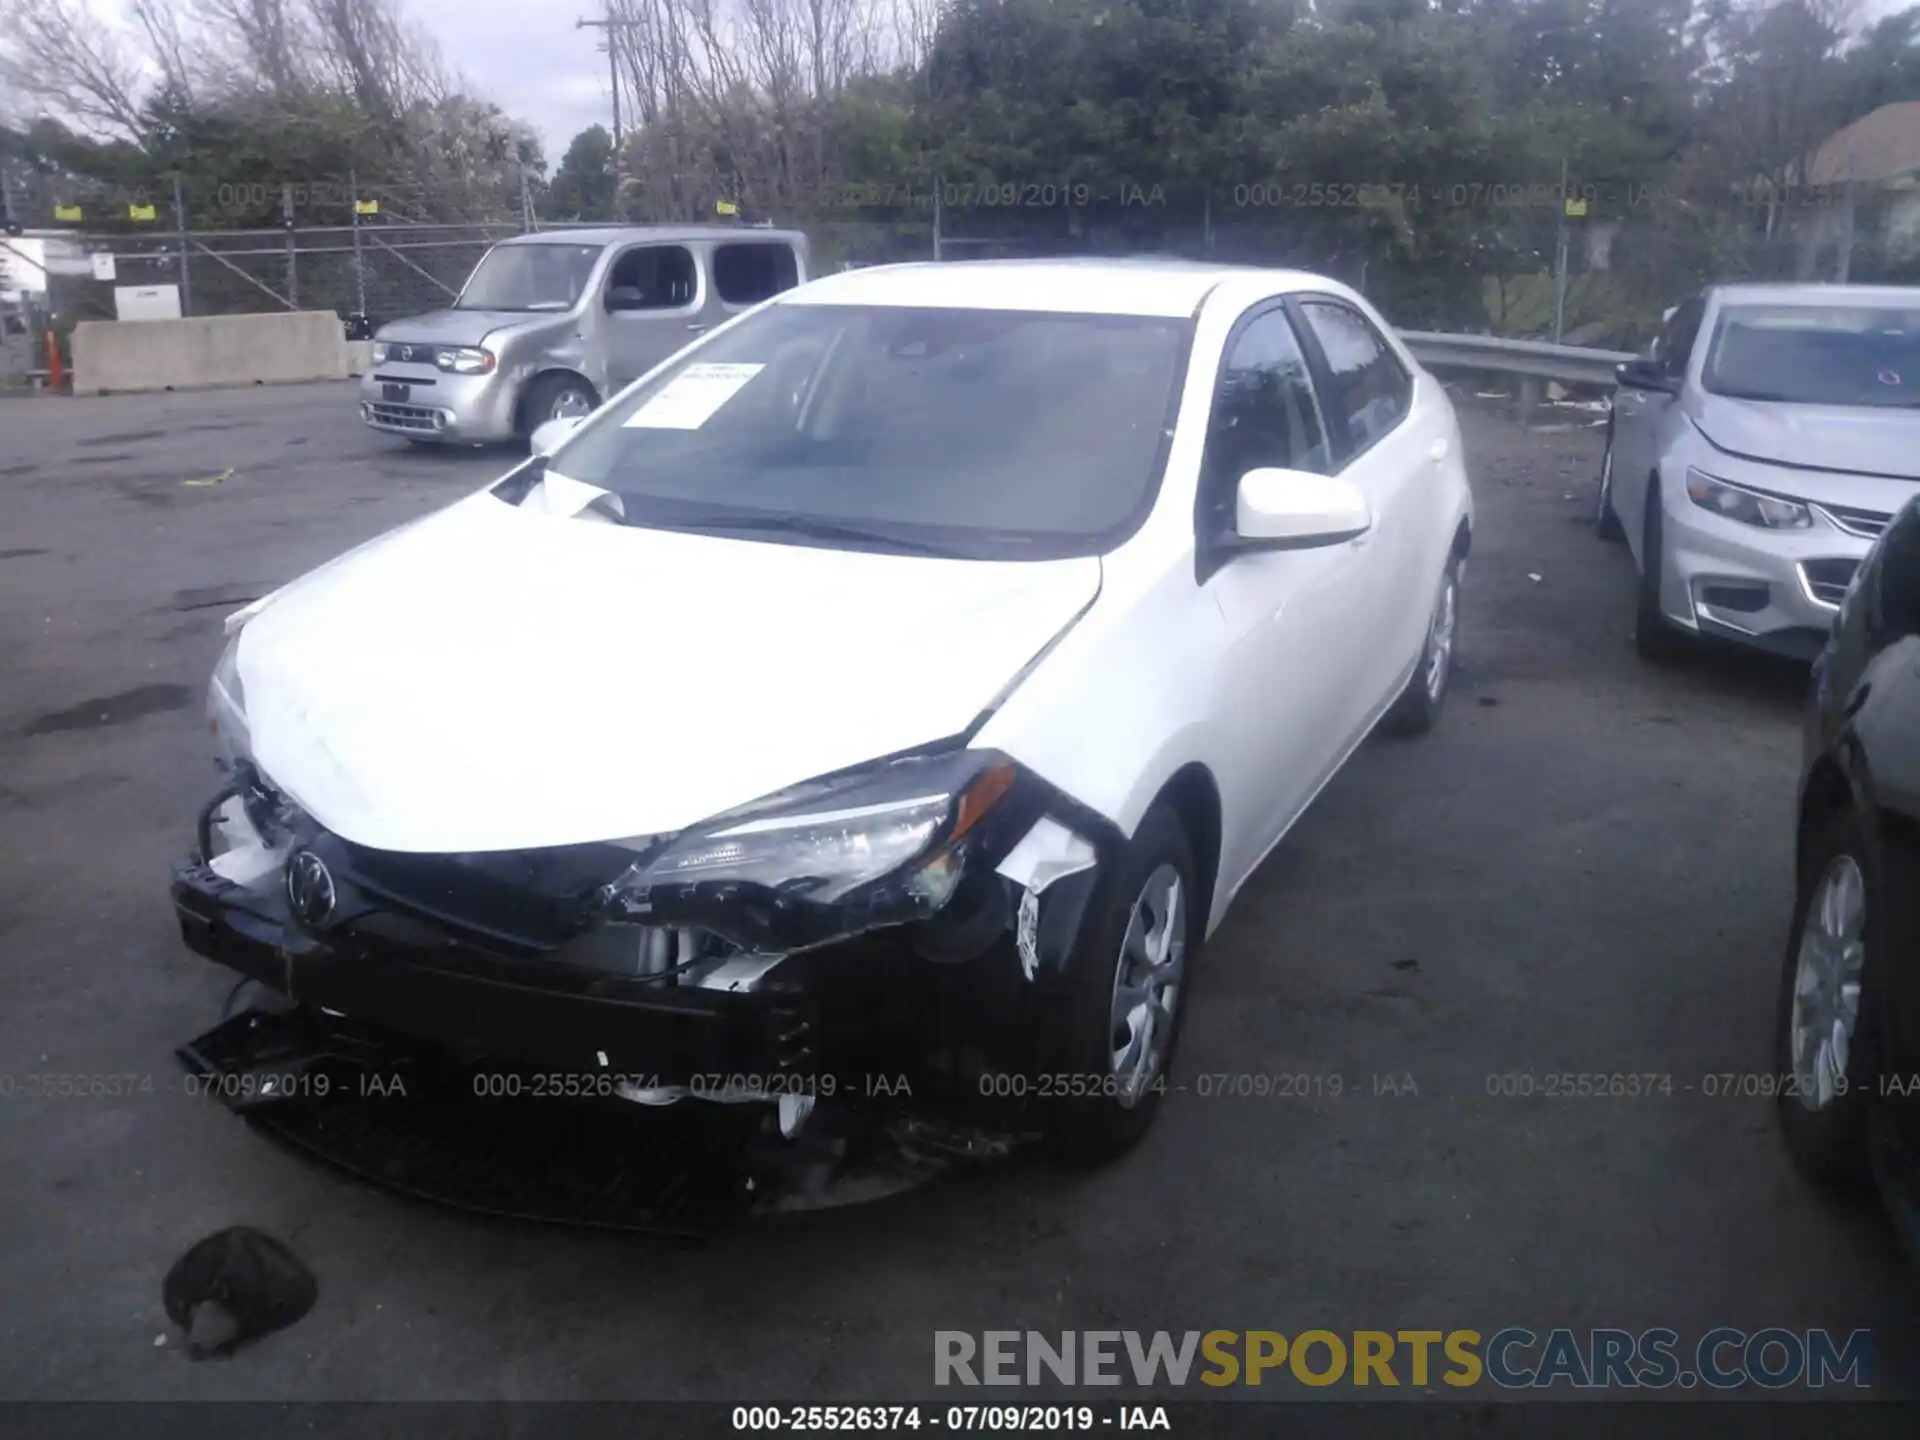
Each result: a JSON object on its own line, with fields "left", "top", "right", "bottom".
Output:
{"left": 1046, "top": 803, "right": 1204, "bottom": 1164}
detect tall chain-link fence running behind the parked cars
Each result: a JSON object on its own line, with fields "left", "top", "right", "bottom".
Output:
{"left": 10, "top": 167, "right": 1920, "bottom": 378}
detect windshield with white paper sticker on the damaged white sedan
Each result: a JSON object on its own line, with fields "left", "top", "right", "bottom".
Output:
{"left": 533, "top": 303, "right": 1190, "bottom": 559}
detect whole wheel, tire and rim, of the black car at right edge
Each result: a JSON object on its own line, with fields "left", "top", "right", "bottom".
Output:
{"left": 1774, "top": 808, "right": 1899, "bottom": 1188}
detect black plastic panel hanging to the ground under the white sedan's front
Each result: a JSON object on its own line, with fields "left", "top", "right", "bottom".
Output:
{"left": 179, "top": 1012, "right": 756, "bottom": 1236}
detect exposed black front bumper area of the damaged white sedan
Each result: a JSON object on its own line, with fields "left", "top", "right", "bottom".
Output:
{"left": 171, "top": 779, "right": 1121, "bottom": 1108}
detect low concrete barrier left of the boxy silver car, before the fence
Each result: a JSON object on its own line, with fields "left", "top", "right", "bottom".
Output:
{"left": 73, "top": 311, "right": 351, "bottom": 396}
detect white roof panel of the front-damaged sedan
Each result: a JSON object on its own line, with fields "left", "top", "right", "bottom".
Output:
{"left": 781, "top": 255, "right": 1331, "bottom": 319}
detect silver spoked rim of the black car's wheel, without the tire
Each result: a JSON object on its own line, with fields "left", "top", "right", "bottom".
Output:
{"left": 1788, "top": 854, "right": 1866, "bottom": 1110}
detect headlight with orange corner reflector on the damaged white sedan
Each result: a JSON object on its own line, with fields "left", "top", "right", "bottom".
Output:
{"left": 603, "top": 751, "right": 1016, "bottom": 948}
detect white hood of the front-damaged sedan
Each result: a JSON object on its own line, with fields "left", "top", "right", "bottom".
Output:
{"left": 236, "top": 493, "right": 1100, "bottom": 852}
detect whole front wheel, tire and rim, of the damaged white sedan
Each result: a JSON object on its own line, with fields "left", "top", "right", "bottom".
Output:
{"left": 1046, "top": 803, "right": 1204, "bottom": 1162}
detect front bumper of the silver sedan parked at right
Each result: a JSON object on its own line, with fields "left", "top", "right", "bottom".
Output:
{"left": 1661, "top": 490, "right": 1872, "bottom": 660}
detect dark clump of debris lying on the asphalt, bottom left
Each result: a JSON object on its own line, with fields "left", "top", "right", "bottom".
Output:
{"left": 156, "top": 1225, "right": 321, "bottom": 1359}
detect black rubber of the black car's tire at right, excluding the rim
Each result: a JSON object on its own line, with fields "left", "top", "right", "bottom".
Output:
{"left": 1774, "top": 804, "right": 1889, "bottom": 1194}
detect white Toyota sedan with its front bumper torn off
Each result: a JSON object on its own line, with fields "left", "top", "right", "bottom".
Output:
{"left": 173, "top": 261, "right": 1473, "bottom": 1156}
